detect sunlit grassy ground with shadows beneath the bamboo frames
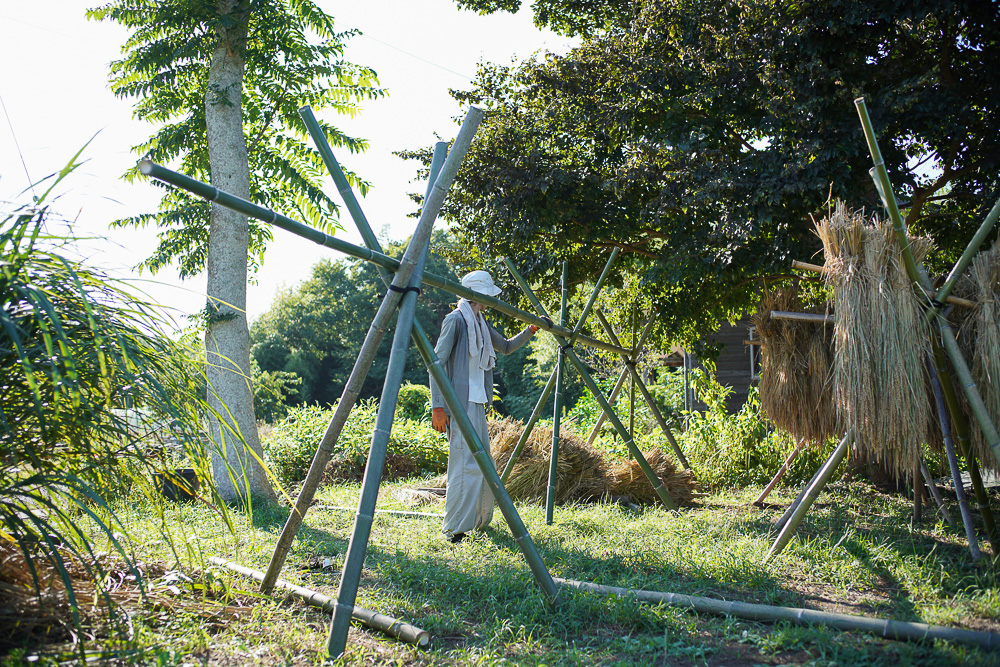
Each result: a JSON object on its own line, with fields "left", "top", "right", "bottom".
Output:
{"left": 7, "top": 483, "right": 1000, "bottom": 666}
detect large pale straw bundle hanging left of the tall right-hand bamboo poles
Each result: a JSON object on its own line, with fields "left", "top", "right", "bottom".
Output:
{"left": 816, "top": 202, "right": 939, "bottom": 477}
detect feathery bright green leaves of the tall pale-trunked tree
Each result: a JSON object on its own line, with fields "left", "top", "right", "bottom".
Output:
{"left": 87, "top": 0, "right": 384, "bottom": 277}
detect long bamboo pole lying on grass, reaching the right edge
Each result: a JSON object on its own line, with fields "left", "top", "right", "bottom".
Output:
{"left": 556, "top": 578, "right": 1000, "bottom": 651}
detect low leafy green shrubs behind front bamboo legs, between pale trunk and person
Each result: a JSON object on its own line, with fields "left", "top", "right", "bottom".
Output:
{"left": 263, "top": 400, "right": 448, "bottom": 484}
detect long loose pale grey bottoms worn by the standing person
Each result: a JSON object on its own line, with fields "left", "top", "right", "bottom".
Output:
{"left": 444, "top": 403, "right": 493, "bottom": 539}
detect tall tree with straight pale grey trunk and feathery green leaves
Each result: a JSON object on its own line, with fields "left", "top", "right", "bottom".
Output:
{"left": 88, "top": 0, "right": 381, "bottom": 501}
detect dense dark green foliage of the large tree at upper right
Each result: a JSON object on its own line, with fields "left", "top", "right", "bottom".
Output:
{"left": 425, "top": 0, "right": 1000, "bottom": 352}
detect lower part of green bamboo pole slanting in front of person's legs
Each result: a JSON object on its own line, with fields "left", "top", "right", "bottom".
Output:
{"left": 413, "top": 322, "right": 559, "bottom": 606}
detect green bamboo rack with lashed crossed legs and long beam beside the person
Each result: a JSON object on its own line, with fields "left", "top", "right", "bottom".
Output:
{"left": 139, "top": 107, "right": 696, "bottom": 657}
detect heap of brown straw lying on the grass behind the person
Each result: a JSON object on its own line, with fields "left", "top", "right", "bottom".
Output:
{"left": 427, "top": 417, "right": 699, "bottom": 504}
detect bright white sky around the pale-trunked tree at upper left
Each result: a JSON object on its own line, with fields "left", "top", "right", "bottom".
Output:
{"left": 0, "top": 0, "right": 571, "bottom": 320}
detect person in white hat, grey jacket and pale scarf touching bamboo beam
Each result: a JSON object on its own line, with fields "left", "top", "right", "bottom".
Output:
{"left": 430, "top": 271, "right": 538, "bottom": 544}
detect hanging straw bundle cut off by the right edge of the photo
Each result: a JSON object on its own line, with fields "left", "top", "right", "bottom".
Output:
{"left": 955, "top": 243, "right": 1000, "bottom": 471}
